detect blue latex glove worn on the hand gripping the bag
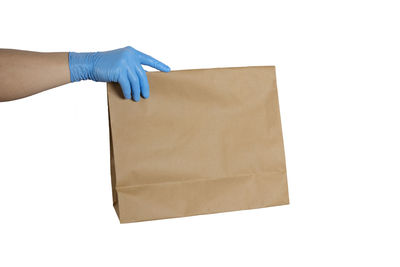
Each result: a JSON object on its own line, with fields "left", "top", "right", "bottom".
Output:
{"left": 69, "top": 46, "right": 170, "bottom": 101}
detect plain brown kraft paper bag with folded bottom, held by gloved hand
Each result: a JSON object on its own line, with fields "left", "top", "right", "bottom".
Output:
{"left": 108, "top": 66, "right": 289, "bottom": 223}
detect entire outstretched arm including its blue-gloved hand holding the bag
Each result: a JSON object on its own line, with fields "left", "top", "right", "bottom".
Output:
{"left": 0, "top": 46, "right": 170, "bottom": 101}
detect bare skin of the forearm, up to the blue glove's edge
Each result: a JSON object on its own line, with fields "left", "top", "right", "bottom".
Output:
{"left": 0, "top": 49, "right": 70, "bottom": 101}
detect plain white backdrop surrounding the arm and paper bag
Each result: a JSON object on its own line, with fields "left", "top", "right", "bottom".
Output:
{"left": 0, "top": 0, "right": 400, "bottom": 266}
